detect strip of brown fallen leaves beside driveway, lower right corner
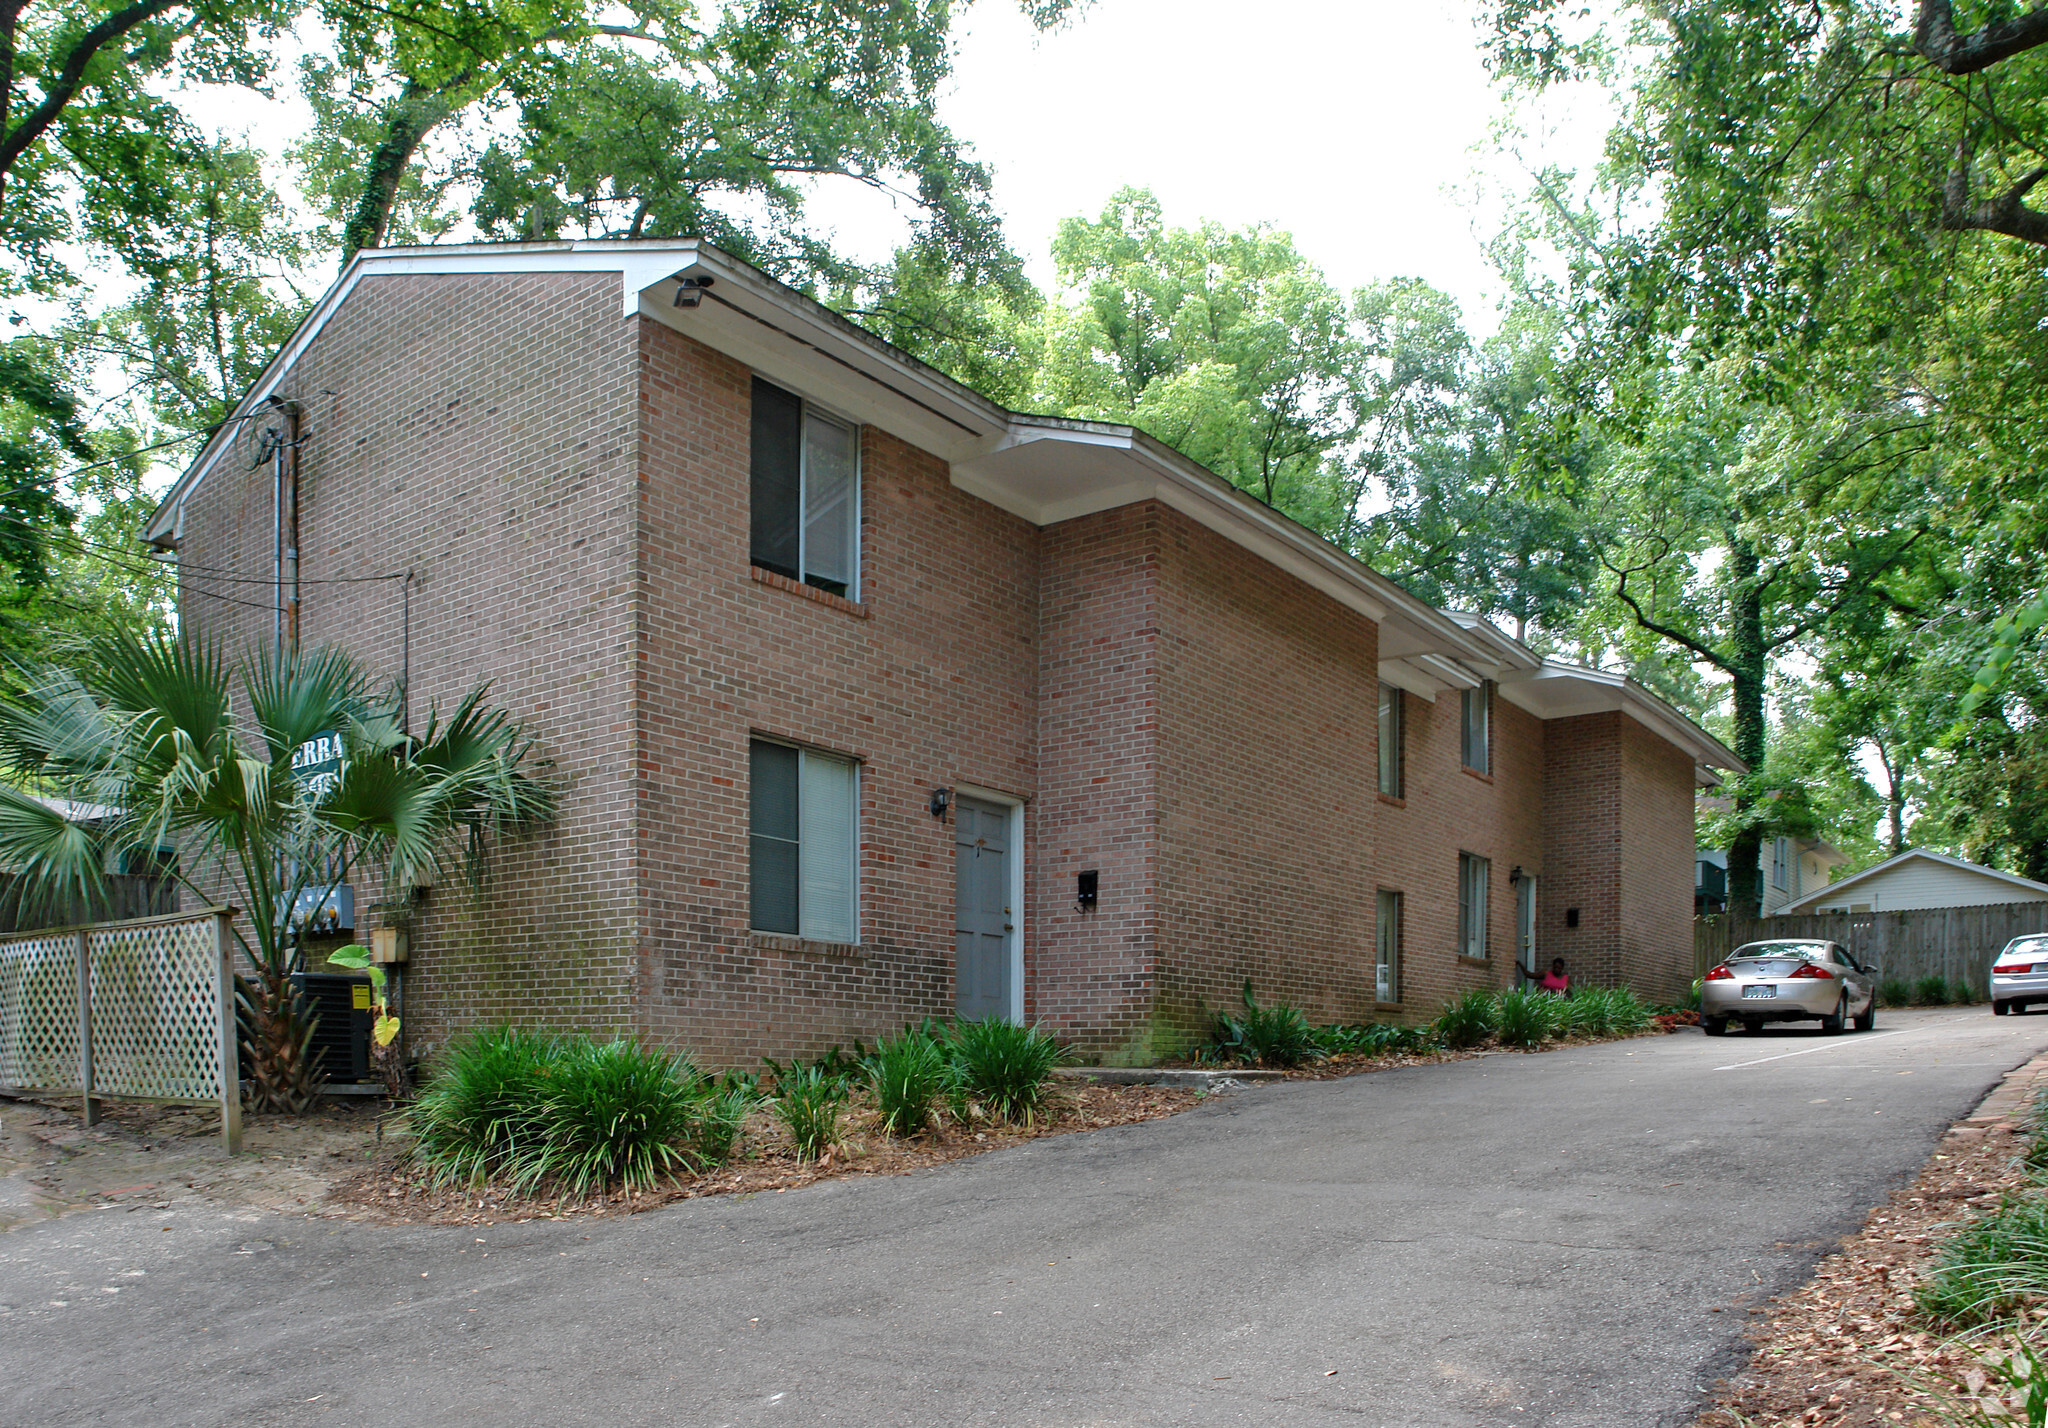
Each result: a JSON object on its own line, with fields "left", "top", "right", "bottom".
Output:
{"left": 1696, "top": 1063, "right": 2048, "bottom": 1428}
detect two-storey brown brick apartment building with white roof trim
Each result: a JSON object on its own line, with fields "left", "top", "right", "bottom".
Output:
{"left": 147, "top": 242, "right": 1739, "bottom": 1063}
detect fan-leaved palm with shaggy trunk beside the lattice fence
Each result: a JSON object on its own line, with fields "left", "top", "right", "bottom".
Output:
{"left": 0, "top": 635, "right": 553, "bottom": 1112}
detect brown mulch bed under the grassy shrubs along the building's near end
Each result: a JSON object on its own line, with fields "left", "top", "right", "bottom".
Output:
{"left": 328, "top": 1084, "right": 1204, "bottom": 1225}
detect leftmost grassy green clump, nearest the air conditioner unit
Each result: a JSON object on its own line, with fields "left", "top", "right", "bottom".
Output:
{"left": 406, "top": 1026, "right": 561, "bottom": 1184}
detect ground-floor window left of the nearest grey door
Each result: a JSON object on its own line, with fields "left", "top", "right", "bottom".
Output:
{"left": 748, "top": 740, "right": 860, "bottom": 942}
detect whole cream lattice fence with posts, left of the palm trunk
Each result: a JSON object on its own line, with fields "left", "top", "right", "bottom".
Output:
{"left": 0, "top": 908, "right": 242, "bottom": 1153}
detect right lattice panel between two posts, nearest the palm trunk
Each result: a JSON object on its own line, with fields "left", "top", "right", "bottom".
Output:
{"left": 86, "top": 916, "right": 221, "bottom": 1100}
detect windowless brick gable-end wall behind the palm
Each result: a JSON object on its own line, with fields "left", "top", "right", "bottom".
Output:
{"left": 178, "top": 275, "right": 635, "bottom": 1051}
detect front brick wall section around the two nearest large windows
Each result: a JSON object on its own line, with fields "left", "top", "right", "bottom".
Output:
{"left": 635, "top": 324, "right": 1040, "bottom": 1065}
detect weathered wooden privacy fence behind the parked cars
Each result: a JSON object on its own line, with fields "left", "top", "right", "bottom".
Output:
{"left": 1692, "top": 901, "right": 2048, "bottom": 996}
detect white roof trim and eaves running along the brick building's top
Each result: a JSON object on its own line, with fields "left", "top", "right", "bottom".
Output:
{"left": 143, "top": 240, "right": 1743, "bottom": 783}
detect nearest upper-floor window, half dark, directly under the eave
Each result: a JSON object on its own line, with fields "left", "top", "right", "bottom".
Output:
{"left": 750, "top": 377, "right": 860, "bottom": 600}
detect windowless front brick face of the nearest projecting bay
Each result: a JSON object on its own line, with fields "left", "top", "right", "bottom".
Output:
{"left": 1153, "top": 510, "right": 1378, "bottom": 1051}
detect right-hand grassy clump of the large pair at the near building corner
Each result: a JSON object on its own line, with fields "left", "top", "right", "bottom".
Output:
{"left": 514, "top": 1039, "right": 709, "bottom": 1196}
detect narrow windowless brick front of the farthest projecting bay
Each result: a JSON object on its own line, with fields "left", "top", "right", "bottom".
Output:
{"left": 1620, "top": 719, "right": 1698, "bottom": 1002}
